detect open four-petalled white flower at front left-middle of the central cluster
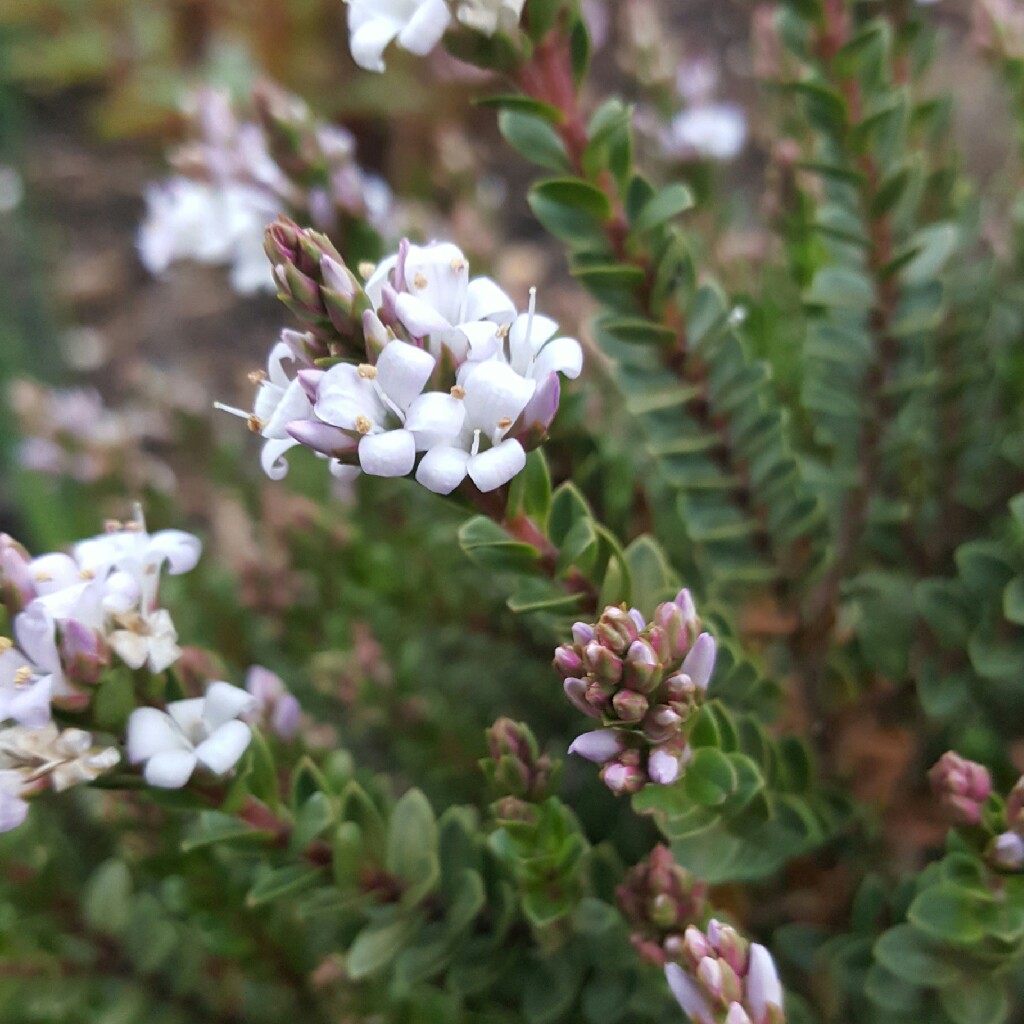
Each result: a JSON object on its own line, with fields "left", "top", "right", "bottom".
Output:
{"left": 314, "top": 341, "right": 465, "bottom": 476}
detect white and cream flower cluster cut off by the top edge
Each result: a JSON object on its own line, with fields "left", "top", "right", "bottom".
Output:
{"left": 346, "top": 0, "right": 525, "bottom": 72}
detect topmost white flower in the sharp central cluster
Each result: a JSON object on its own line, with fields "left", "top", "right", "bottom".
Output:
{"left": 366, "top": 242, "right": 516, "bottom": 362}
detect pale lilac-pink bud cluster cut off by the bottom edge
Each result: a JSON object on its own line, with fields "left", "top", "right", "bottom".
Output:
{"left": 665, "top": 919, "right": 785, "bottom": 1024}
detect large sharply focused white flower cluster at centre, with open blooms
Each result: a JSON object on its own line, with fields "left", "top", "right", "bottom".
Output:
{"left": 218, "top": 242, "right": 583, "bottom": 495}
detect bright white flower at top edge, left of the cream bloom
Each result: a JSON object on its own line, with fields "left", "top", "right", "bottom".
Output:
{"left": 348, "top": 0, "right": 452, "bottom": 71}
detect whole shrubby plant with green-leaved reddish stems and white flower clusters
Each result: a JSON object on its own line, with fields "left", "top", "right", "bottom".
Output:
{"left": 6, "top": 0, "right": 1024, "bottom": 1024}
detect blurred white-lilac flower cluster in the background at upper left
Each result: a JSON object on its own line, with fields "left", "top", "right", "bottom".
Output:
{"left": 138, "top": 84, "right": 391, "bottom": 294}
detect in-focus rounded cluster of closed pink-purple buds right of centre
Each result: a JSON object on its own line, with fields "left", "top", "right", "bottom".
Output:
{"left": 554, "top": 590, "right": 716, "bottom": 794}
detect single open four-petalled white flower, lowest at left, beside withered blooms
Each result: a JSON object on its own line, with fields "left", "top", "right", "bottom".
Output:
{"left": 128, "top": 682, "right": 256, "bottom": 790}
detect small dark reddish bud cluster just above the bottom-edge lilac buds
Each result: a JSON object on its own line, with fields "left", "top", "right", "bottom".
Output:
{"left": 615, "top": 845, "right": 708, "bottom": 967}
